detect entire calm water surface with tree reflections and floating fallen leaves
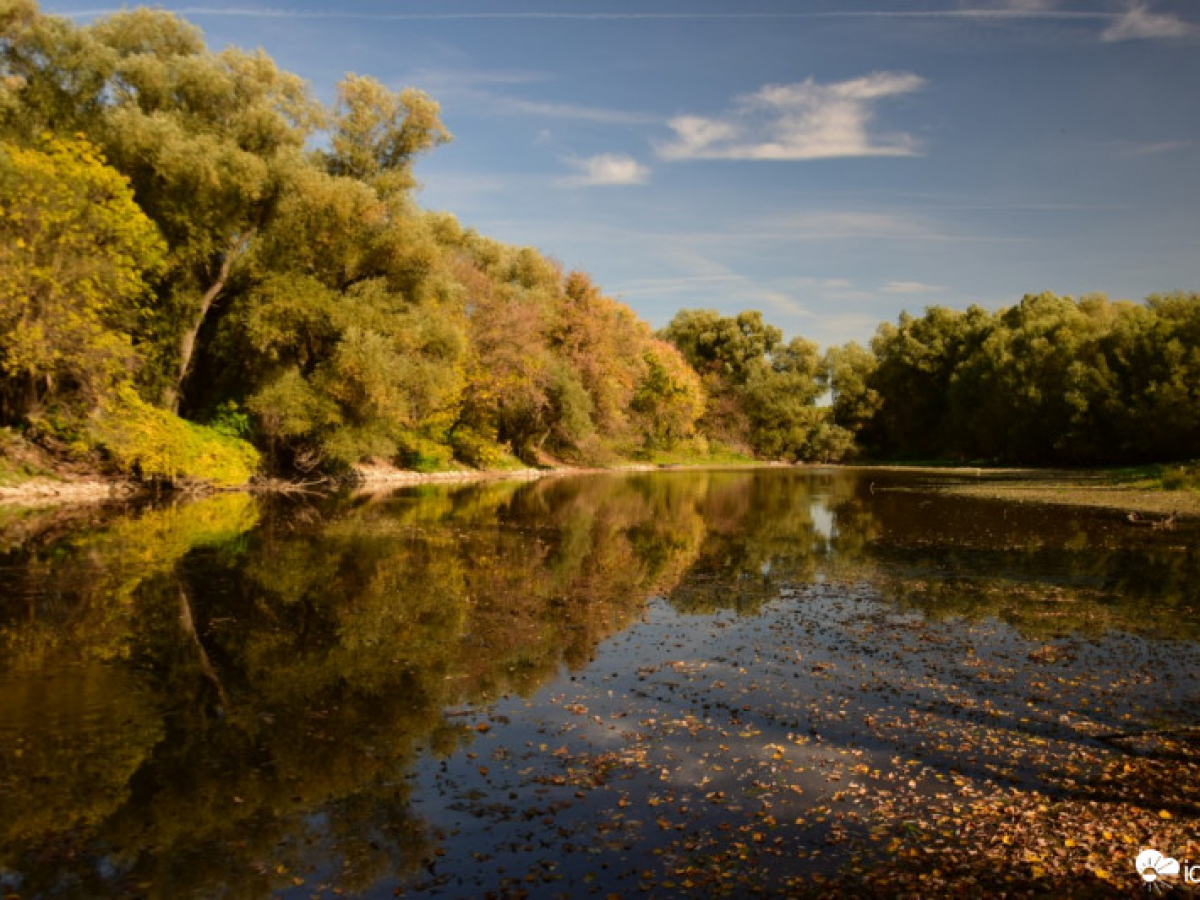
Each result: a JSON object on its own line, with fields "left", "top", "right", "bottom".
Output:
{"left": 0, "top": 469, "right": 1200, "bottom": 898}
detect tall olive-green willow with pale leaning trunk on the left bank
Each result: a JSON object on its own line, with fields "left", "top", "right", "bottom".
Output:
{"left": 91, "top": 10, "right": 323, "bottom": 408}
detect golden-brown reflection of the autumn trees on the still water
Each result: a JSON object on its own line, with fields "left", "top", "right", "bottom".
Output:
{"left": 0, "top": 469, "right": 1200, "bottom": 896}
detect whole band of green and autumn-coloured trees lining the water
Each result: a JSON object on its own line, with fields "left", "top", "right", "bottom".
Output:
{"left": 0, "top": 0, "right": 1200, "bottom": 484}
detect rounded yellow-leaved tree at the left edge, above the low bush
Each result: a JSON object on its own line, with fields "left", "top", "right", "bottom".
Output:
{"left": 0, "top": 138, "right": 164, "bottom": 422}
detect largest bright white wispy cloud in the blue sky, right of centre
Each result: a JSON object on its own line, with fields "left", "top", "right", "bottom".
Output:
{"left": 658, "top": 72, "right": 925, "bottom": 160}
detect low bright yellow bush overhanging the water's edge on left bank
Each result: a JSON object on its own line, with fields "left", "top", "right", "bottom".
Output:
{"left": 88, "top": 385, "right": 260, "bottom": 487}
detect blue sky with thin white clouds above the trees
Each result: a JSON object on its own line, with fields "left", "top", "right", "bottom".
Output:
{"left": 41, "top": 0, "right": 1200, "bottom": 347}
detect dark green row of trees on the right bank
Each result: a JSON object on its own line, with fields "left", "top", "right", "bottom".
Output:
{"left": 827, "top": 292, "right": 1200, "bottom": 466}
